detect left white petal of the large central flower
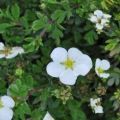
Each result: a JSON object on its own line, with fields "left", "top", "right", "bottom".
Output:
{"left": 46, "top": 62, "right": 65, "bottom": 77}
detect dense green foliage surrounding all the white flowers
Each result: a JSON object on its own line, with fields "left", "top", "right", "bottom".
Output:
{"left": 0, "top": 0, "right": 120, "bottom": 120}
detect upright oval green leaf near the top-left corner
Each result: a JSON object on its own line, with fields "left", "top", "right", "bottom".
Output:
{"left": 11, "top": 4, "right": 20, "bottom": 20}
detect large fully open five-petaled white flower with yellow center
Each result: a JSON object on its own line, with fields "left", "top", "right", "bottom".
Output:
{"left": 47, "top": 47, "right": 92, "bottom": 85}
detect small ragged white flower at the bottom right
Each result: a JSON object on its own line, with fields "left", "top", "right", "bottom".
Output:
{"left": 90, "top": 98, "right": 103, "bottom": 113}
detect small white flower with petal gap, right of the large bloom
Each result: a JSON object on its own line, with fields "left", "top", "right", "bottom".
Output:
{"left": 95, "top": 59, "right": 110, "bottom": 78}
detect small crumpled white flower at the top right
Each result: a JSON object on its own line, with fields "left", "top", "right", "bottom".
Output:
{"left": 89, "top": 10, "right": 111, "bottom": 32}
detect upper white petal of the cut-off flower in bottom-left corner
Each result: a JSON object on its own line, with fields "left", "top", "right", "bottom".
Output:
{"left": 1, "top": 96, "right": 15, "bottom": 108}
